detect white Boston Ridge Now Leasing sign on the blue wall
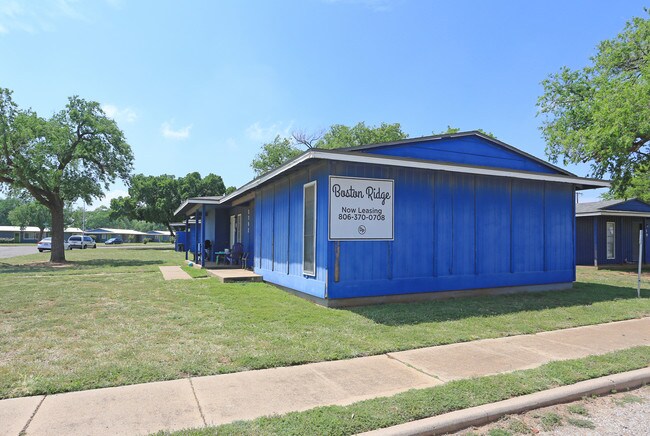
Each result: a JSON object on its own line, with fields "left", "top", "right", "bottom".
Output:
{"left": 329, "top": 176, "right": 394, "bottom": 241}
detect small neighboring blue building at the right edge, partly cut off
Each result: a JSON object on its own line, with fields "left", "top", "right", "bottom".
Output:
{"left": 576, "top": 199, "right": 650, "bottom": 266}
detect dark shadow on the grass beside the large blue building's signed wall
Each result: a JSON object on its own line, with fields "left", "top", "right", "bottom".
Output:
{"left": 339, "top": 282, "right": 650, "bottom": 326}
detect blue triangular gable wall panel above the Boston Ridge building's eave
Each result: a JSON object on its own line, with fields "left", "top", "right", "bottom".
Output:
{"left": 363, "top": 136, "right": 558, "bottom": 174}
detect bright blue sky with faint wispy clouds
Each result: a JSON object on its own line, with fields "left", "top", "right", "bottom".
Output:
{"left": 0, "top": 0, "right": 645, "bottom": 207}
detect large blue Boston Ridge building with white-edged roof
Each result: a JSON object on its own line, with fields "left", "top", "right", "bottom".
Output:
{"left": 177, "top": 132, "right": 608, "bottom": 306}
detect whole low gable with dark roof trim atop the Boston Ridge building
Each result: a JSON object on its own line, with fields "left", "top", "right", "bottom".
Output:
{"left": 338, "top": 130, "right": 575, "bottom": 176}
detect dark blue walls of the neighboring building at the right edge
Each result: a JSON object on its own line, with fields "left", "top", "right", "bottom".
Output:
{"left": 576, "top": 215, "right": 650, "bottom": 265}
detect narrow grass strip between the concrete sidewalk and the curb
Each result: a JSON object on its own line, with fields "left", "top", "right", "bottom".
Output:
{"left": 159, "top": 347, "right": 650, "bottom": 436}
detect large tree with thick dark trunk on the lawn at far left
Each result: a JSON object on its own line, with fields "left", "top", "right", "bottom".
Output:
{"left": 0, "top": 88, "right": 133, "bottom": 262}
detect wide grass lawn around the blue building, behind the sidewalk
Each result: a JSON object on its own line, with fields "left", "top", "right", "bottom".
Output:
{"left": 0, "top": 247, "right": 650, "bottom": 398}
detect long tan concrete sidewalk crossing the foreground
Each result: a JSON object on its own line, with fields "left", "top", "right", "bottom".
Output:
{"left": 0, "top": 318, "right": 650, "bottom": 435}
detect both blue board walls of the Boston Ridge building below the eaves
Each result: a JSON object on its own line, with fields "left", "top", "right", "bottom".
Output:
{"left": 254, "top": 158, "right": 575, "bottom": 299}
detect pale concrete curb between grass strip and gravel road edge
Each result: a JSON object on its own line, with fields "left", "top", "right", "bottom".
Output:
{"left": 362, "top": 367, "right": 650, "bottom": 436}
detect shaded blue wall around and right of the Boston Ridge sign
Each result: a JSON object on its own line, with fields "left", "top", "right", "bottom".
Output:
{"left": 326, "top": 163, "right": 575, "bottom": 298}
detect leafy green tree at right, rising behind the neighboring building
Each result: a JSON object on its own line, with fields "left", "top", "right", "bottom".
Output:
{"left": 537, "top": 10, "right": 650, "bottom": 196}
